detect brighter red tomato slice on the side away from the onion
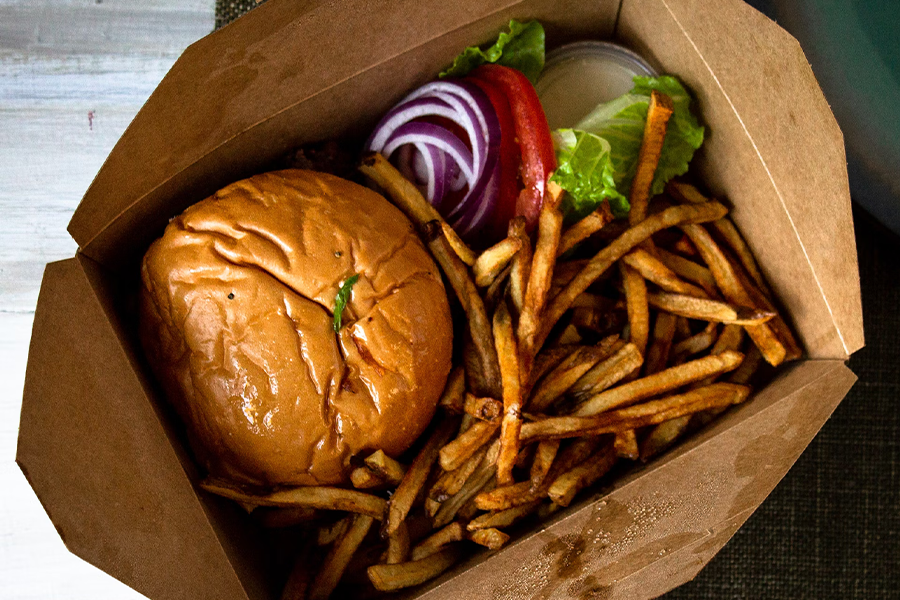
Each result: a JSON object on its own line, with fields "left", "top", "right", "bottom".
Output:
{"left": 469, "top": 64, "right": 556, "bottom": 231}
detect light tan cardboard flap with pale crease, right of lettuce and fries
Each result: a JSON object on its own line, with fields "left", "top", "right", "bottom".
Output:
{"left": 616, "top": 0, "right": 863, "bottom": 358}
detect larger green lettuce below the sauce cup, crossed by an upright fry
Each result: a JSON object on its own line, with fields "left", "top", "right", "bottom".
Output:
{"left": 553, "top": 76, "right": 705, "bottom": 220}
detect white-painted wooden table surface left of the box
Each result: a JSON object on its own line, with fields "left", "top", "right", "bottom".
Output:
{"left": 0, "top": 0, "right": 215, "bottom": 600}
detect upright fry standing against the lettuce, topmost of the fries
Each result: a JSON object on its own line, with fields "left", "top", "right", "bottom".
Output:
{"left": 628, "top": 90, "right": 674, "bottom": 227}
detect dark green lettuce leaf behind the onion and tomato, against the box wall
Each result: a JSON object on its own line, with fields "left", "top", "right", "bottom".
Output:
{"left": 440, "top": 20, "right": 544, "bottom": 83}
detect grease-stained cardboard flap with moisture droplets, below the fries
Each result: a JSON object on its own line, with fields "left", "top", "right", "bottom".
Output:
{"left": 409, "top": 360, "right": 856, "bottom": 600}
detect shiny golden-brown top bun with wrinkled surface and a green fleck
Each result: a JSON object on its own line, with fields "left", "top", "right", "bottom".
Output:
{"left": 141, "top": 170, "right": 452, "bottom": 487}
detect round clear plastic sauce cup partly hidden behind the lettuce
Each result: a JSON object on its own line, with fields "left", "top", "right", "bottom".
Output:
{"left": 535, "top": 41, "right": 657, "bottom": 129}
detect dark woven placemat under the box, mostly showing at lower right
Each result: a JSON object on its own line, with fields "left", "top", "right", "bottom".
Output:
{"left": 216, "top": 0, "right": 900, "bottom": 600}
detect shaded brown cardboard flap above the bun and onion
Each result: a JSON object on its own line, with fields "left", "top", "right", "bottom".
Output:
{"left": 69, "top": 0, "right": 619, "bottom": 265}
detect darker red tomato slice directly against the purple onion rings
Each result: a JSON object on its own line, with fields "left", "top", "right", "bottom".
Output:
{"left": 468, "top": 78, "right": 522, "bottom": 243}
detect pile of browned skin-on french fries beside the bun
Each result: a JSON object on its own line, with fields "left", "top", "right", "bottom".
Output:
{"left": 203, "top": 93, "right": 801, "bottom": 600}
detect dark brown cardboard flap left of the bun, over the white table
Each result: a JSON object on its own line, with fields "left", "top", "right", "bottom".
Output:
{"left": 16, "top": 258, "right": 268, "bottom": 600}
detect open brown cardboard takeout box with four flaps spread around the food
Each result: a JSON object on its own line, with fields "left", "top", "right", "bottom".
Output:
{"left": 17, "top": 0, "right": 863, "bottom": 600}
